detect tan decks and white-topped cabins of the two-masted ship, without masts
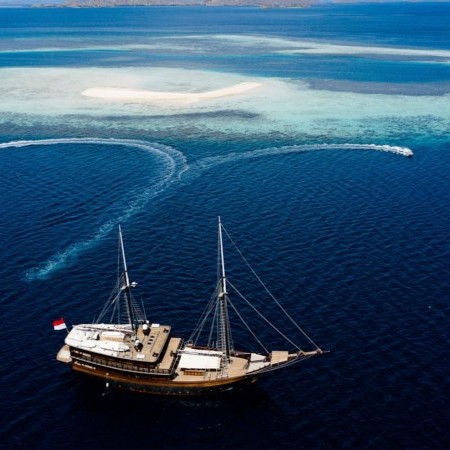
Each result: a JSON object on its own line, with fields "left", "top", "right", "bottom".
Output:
{"left": 58, "top": 324, "right": 308, "bottom": 383}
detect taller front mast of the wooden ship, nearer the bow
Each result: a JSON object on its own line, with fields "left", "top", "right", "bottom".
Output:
{"left": 217, "top": 216, "right": 231, "bottom": 366}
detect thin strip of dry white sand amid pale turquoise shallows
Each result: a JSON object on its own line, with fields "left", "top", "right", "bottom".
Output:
{"left": 82, "top": 82, "right": 262, "bottom": 103}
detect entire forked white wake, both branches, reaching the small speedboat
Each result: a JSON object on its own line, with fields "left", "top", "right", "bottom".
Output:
{"left": 0, "top": 138, "right": 413, "bottom": 281}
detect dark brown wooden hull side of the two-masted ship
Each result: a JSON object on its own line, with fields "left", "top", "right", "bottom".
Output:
{"left": 72, "top": 362, "right": 261, "bottom": 396}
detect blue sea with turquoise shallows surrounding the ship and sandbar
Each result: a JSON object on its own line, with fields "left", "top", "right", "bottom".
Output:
{"left": 0, "top": 3, "right": 450, "bottom": 449}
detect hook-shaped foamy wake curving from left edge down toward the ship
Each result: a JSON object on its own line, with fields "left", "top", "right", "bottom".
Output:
{"left": 0, "top": 138, "right": 188, "bottom": 281}
